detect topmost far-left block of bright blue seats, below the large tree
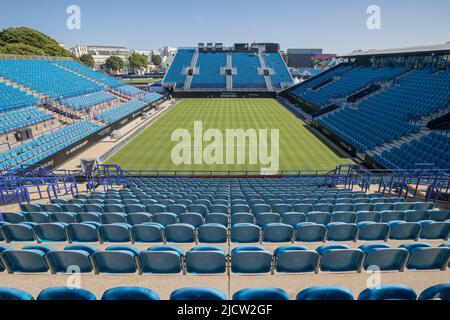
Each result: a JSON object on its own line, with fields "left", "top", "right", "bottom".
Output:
{"left": 0, "top": 60, "right": 102, "bottom": 99}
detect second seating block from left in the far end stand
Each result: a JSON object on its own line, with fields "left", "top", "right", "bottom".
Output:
{"left": 191, "top": 52, "right": 227, "bottom": 90}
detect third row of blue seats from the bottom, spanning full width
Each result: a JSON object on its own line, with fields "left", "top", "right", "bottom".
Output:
{"left": 0, "top": 221, "right": 450, "bottom": 243}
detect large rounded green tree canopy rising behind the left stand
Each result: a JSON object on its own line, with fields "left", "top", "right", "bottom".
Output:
{"left": 0, "top": 27, "right": 74, "bottom": 58}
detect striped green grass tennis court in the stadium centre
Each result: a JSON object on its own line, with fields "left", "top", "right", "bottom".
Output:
{"left": 107, "top": 99, "right": 351, "bottom": 171}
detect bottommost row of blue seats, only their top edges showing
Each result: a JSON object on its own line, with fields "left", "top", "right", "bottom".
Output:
{"left": 0, "top": 283, "right": 450, "bottom": 301}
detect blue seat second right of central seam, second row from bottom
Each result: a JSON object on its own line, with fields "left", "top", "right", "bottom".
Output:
{"left": 274, "top": 246, "right": 319, "bottom": 273}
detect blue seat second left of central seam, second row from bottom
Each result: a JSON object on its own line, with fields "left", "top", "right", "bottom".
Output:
{"left": 139, "top": 246, "right": 183, "bottom": 274}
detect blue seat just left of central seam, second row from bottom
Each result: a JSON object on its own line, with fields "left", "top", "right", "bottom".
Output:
{"left": 186, "top": 247, "right": 227, "bottom": 274}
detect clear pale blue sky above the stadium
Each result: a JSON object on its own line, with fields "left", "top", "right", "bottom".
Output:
{"left": 0, "top": 0, "right": 450, "bottom": 54}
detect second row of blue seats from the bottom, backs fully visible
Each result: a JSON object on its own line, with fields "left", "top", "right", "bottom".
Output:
{"left": 0, "top": 243, "right": 450, "bottom": 274}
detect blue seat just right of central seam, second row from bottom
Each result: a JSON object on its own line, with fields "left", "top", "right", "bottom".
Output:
{"left": 231, "top": 247, "right": 272, "bottom": 273}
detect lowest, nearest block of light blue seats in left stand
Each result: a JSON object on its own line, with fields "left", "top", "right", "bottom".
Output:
{"left": 0, "top": 120, "right": 101, "bottom": 171}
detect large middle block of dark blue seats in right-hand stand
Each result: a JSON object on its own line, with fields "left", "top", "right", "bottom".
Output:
{"left": 319, "top": 69, "right": 450, "bottom": 152}
